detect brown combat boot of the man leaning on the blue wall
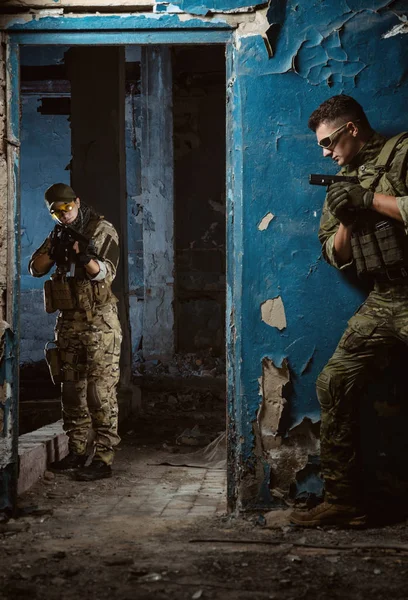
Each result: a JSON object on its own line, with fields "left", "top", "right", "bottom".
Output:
{"left": 289, "top": 502, "right": 367, "bottom": 528}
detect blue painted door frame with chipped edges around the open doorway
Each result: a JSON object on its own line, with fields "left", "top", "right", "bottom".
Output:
{"left": 0, "top": 13, "right": 244, "bottom": 510}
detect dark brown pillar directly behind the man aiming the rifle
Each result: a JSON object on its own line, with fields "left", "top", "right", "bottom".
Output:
{"left": 66, "top": 46, "right": 131, "bottom": 383}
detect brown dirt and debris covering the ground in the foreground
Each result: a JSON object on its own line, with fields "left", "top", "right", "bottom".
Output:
{"left": 0, "top": 399, "right": 408, "bottom": 600}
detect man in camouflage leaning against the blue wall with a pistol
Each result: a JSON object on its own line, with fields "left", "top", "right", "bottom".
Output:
{"left": 291, "top": 95, "right": 408, "bottom": 527}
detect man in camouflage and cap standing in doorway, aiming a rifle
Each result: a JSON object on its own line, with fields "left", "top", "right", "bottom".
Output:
{"left": 29, "top": 183, "right": 122, "bottom": 481}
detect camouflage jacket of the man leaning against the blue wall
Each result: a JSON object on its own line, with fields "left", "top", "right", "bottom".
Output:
{"left": 318, "top": 132, "right": 408, "bottom": 269}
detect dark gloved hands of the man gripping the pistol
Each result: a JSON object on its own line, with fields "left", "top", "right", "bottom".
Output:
{"left": 327, "top": 182, "right": 374, "bottom": 226}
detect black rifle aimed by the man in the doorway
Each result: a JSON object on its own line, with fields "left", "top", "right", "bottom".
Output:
{"left": 50, "top": 224, "right": 90, "bottom": 277}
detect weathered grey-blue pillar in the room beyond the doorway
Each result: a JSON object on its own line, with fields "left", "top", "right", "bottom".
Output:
{"left": 141, "top": 44, "right": 174, "bottom": 361}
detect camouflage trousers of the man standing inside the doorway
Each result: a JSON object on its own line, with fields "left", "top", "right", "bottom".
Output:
{"left": 55, "top": 305, "right": 122, "bottom": 464}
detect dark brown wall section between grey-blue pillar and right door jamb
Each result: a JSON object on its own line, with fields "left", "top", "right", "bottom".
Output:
{"left": 172, "top": 46, "right": 226, "bottom": 356}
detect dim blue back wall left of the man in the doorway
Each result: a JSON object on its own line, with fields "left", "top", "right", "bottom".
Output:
{"left": 20, "top": 47, "right": 71, "bottom": 364}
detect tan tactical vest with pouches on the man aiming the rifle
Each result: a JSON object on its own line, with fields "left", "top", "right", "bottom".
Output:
{"left": 44, "top": 215, "right": 117, "bottom": 321}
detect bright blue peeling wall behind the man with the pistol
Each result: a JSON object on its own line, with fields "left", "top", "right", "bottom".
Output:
{"left": 230, "top": 0, "right": 408, "bottom": 504}
